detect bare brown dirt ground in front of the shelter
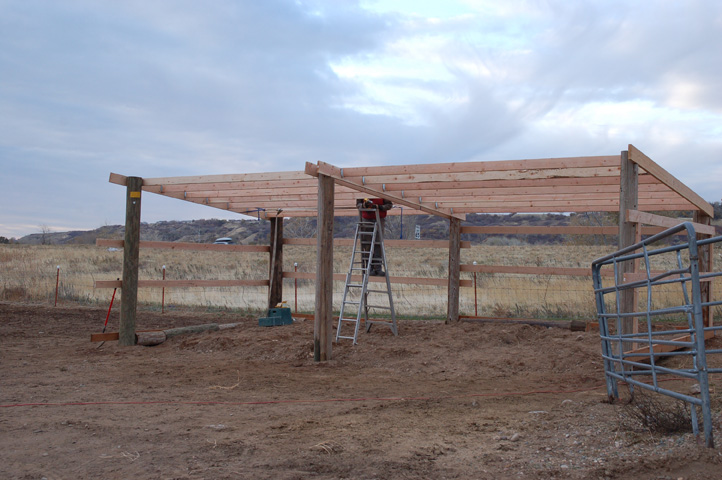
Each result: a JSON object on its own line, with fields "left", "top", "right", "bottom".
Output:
{"left": 0, "top": 302, "right": 722, "bottom": 479}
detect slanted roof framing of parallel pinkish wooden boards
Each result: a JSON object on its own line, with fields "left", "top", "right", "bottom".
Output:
{"left": 110, "top": 145, "right": 713, "bottom": 218}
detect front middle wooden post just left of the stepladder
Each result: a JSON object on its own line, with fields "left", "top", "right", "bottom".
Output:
{"left": 313, "top": 174, "right": 334, "bottom": 362}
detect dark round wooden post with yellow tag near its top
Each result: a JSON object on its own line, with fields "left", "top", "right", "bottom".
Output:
{"left": 118, "top": 177, "right": 143, "bottom": 346}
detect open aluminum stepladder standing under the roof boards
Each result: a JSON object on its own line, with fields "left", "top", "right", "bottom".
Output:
{"left": 336, "top": 208, "right": 398, "bottom": 345}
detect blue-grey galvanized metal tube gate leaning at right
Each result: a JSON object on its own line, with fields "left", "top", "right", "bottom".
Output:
{"left": 592, "top": 222, "right": 722, "bottom": 447}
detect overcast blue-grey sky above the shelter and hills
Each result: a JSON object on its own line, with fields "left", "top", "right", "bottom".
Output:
{"left": 0, "top": 0, "right": 722, "bottom": 237}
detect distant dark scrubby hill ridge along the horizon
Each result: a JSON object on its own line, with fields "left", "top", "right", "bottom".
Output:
{"left": 18, "top": 202, "right": 722, "bottom": 245}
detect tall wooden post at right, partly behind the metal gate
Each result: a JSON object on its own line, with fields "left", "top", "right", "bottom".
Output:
{"left": 617, "top": 150, "right": 639, "bottom": 350}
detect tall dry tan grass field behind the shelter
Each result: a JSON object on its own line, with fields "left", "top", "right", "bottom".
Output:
{"left": 0, "top": 245, "right": 722, "bottom": 319}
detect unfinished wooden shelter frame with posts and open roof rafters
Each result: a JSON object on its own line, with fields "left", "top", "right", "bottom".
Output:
{"left": 102, "top": 145, "right": 714, "bottom": 361}
